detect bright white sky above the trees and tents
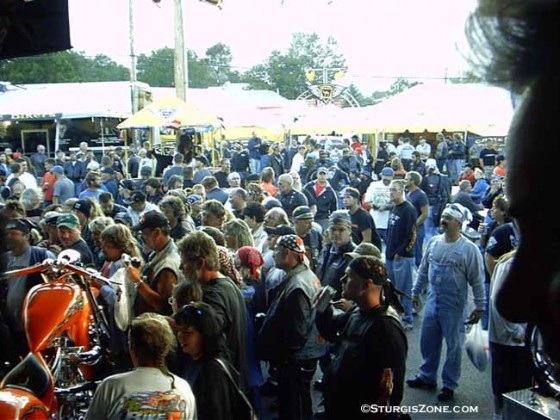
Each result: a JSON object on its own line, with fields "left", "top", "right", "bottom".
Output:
{"left": 69, "top": 0, "right": 476, "bottom": 93}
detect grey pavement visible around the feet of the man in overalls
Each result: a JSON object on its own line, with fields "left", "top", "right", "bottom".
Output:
{"left": 264, "top": 310, "right": 493, "bottom": 420}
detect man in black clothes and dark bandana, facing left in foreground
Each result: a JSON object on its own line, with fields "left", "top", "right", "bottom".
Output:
{"left": 316, "top": 253, "right": 408, "bottom": 419}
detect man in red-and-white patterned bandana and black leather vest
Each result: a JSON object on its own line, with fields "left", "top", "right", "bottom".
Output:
{"left": 258, "top": 235, "right": 326, "bottom": 420}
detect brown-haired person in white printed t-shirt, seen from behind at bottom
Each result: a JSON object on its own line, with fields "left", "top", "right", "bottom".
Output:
{"left": 86, "top": 313, "right": 195, "bottom": 420}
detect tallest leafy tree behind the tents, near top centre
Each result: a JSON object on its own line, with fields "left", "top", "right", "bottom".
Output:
{"left": 241, "top": 32, "right": 346, "bottom": 99}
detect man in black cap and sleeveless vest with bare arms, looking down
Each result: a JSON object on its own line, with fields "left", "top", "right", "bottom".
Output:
{"left": 127, "top": 211, "right": 180, "bottom": 316}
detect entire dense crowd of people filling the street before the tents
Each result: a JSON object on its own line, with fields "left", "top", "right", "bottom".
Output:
{"left": 0, "top": 124, "right": 529, "bottom": 419}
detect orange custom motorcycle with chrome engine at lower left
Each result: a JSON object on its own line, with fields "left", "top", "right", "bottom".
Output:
{"left": 0, "top": 250, "right": 110, "bottom": 419}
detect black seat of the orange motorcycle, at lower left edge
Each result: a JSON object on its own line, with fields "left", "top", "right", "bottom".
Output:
{"left": 0, "top": 353, "right": 52, "bottom": 398}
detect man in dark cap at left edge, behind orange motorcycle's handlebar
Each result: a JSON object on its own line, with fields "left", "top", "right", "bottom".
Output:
{"left": 0, "top": 219, "right": 55, "bottom": 362}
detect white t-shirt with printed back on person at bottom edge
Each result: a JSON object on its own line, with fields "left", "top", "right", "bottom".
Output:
{"left": 86, "top": 367, "right": 197, "bottom": 420}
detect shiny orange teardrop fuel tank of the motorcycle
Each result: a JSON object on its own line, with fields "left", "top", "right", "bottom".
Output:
{"left": 23, "top": 281, "right": 85, "bottom": 352}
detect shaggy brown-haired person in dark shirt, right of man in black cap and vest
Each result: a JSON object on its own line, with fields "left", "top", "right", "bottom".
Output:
{"left": 177, "top": 231, "right": 248, "bottom": 388}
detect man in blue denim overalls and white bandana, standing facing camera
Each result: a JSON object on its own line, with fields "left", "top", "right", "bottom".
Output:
{"left": 407, "top": 204, "right": 485, "bottom": 401}
